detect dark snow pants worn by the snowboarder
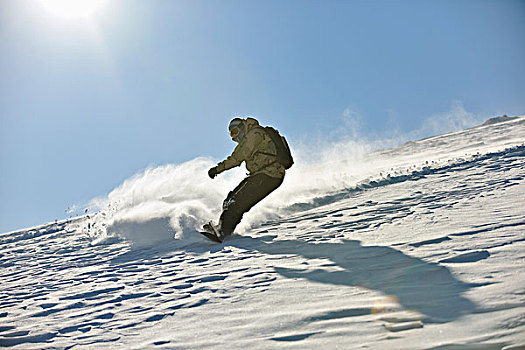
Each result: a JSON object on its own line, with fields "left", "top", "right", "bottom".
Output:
{"left": 219, "top": 174, "right": 283, "bottom": 236}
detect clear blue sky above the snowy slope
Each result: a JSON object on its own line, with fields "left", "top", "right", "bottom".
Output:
{"left": 0, "top": 0, "right": 525, "bottom": 232}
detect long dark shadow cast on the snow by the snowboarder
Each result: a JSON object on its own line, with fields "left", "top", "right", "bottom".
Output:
{"left": 228, "top": 236, "right": 476, "bottom": 323}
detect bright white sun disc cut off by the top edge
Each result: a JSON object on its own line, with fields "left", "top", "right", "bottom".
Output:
{"left": 41, "top": 0, "right": 107, "bottom": 19}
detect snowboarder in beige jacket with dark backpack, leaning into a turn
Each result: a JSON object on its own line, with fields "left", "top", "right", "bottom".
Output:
{"left": 204, "top": 117, "right": 293, "bottom": 241}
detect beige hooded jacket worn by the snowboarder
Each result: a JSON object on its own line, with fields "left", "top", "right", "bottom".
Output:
{"left": 217, "top": 118, "right": 285, "bottom": 178}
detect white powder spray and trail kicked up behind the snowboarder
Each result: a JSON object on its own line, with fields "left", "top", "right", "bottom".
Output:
{"left": 72, "top": 115, "right": 525, "bottom": 247}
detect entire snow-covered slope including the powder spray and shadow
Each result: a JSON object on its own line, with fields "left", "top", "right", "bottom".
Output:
{"left": 0, "top": 117, "right": 525, "bottom": 350}
